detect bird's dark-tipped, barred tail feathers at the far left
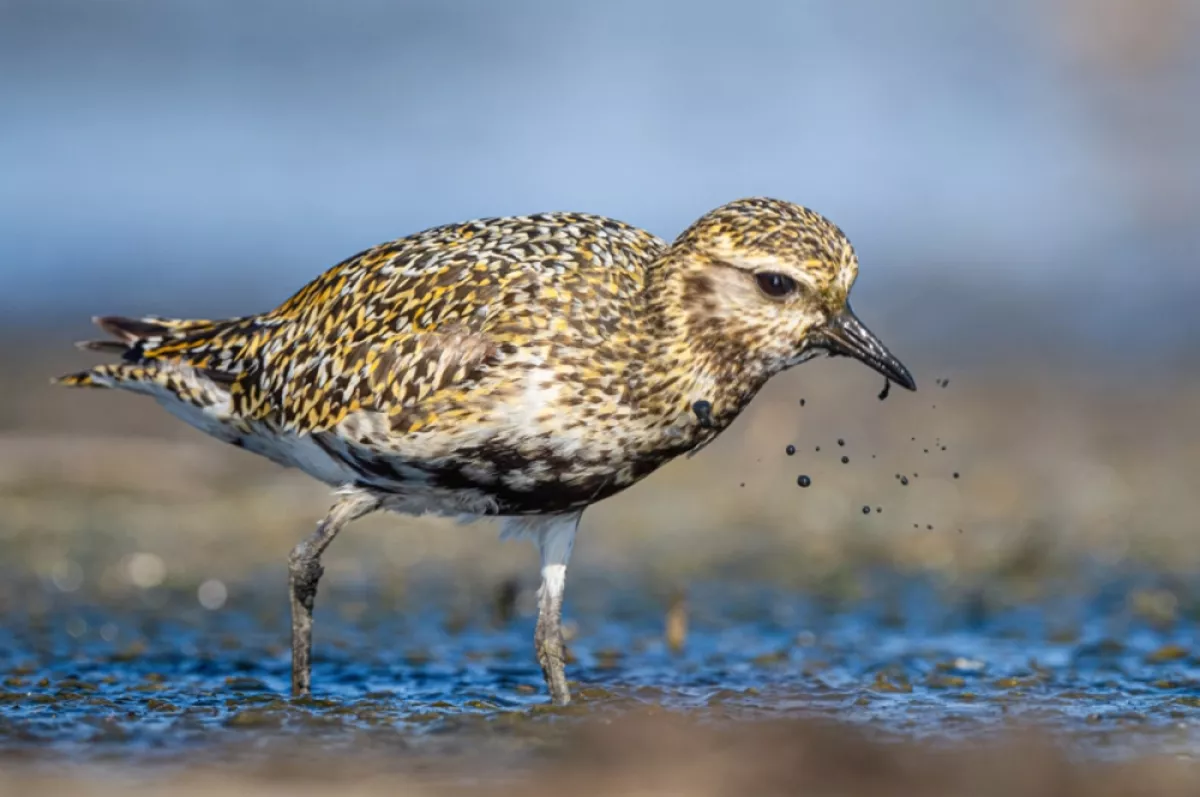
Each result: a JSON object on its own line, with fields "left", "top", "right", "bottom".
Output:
{"left": 54, "top": 316, "right": 241, "bottom": 388}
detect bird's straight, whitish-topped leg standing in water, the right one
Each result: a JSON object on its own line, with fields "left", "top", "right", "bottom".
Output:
{"left": 534, "top": 513, "right": 580, "bottom": 706}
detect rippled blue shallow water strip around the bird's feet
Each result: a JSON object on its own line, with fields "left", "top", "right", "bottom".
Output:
{"left": 0, "top": 566, "right": 1200, "bottom": 763}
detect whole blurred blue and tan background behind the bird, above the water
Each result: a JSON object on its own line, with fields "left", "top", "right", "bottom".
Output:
{"left": 0, "top": 0, "right": 1200, "bottom": 792}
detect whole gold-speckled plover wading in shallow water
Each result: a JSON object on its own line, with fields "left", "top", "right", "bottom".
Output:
{"left": 55, "top": 197, "right": 917, "bottom": 705}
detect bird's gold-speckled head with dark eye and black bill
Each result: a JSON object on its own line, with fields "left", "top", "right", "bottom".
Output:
{"left": 672, "top": 198, "right": 917, "bottom": 390}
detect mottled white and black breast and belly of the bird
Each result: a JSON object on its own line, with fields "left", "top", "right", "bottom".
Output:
{"left": 338, "top": 338, "right": 732, "bottom": 515}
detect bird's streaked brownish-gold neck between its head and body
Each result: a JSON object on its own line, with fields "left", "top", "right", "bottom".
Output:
{"left": 634, "top": 247, "right": 769, "bottom": 442}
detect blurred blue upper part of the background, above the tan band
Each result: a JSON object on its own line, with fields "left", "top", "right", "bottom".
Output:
{"left": 7, "top": 0, "right": 1200, "bottom": 359}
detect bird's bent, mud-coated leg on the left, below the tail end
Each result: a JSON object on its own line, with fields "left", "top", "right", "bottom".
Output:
{"left": 288, "top": 491, "right": 379, "bottom": 697}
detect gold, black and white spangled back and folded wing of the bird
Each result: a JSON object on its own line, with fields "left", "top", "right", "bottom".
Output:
{"left": 66, "top": 214, "right": 665, "bottom": 435}
